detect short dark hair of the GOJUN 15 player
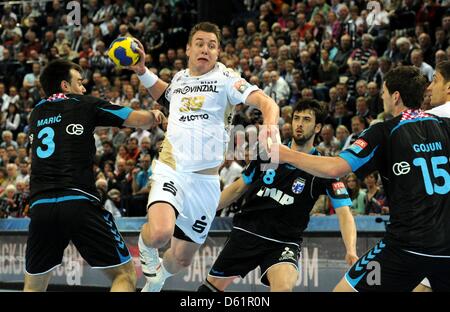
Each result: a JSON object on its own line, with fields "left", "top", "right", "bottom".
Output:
{"left": 384, "top": 66, "right": 428, "bottom": 108}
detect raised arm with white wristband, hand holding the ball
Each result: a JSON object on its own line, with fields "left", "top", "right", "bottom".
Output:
{"left": 128, "top": 39, "right": 169, "bottom": 100}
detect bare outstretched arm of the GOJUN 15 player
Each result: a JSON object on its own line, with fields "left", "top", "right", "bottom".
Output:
{"left": 270, "top": 144, "right": 352, "bottom": 178}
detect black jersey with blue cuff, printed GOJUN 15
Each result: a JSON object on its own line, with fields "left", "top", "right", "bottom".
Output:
{"left": 339, "top": 110, "right": 450, "bottom": 255}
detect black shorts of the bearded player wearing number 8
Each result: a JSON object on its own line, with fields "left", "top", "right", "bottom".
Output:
{"left": 209, "top": 229, "right": 300, "bottom": 286}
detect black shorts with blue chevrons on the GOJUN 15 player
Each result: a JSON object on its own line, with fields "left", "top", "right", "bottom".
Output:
{"left": 345, "top": 241, "right": 450, "bottom": 292}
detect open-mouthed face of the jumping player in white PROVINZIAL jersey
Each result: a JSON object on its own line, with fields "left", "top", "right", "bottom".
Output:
{"left": 186, "top": 31, "right": 220, "bottom": 76}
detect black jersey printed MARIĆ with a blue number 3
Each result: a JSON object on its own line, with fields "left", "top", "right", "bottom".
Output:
{"left": 29, "top": 94, "right": 132, "bottom": 201}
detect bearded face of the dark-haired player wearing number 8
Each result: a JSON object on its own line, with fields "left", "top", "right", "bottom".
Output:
{"left": 292, "top": 110, "right": 320, "bottom": 145}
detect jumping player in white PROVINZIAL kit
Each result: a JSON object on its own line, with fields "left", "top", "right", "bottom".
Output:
{"left": 130, "top": 22, "right": 279, "bottom": 291}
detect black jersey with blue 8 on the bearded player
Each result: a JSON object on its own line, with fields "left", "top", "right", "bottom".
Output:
{"left": 233, "top": 149, "right": 352, "bottom": 243}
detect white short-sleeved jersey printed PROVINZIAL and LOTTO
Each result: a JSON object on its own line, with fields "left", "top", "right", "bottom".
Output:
{"left": 159, "top": 63, "right": 258, "bottom": 172}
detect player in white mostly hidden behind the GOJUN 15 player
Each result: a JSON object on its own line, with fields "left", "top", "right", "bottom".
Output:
{"left": 414, "top": 61, "right": 450, "bottom": 292}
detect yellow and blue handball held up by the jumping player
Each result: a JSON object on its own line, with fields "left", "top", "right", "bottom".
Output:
{"left": 108, "top": 37, "right": 139, "bottom": 66}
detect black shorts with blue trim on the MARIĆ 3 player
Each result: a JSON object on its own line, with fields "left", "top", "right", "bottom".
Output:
{"left": 25, "top": 195, "right": 131, "bottom": 274}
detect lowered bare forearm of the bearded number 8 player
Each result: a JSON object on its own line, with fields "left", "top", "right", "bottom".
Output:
{"left": 335, "top": 206, "right": 358, "bottom": 265}
